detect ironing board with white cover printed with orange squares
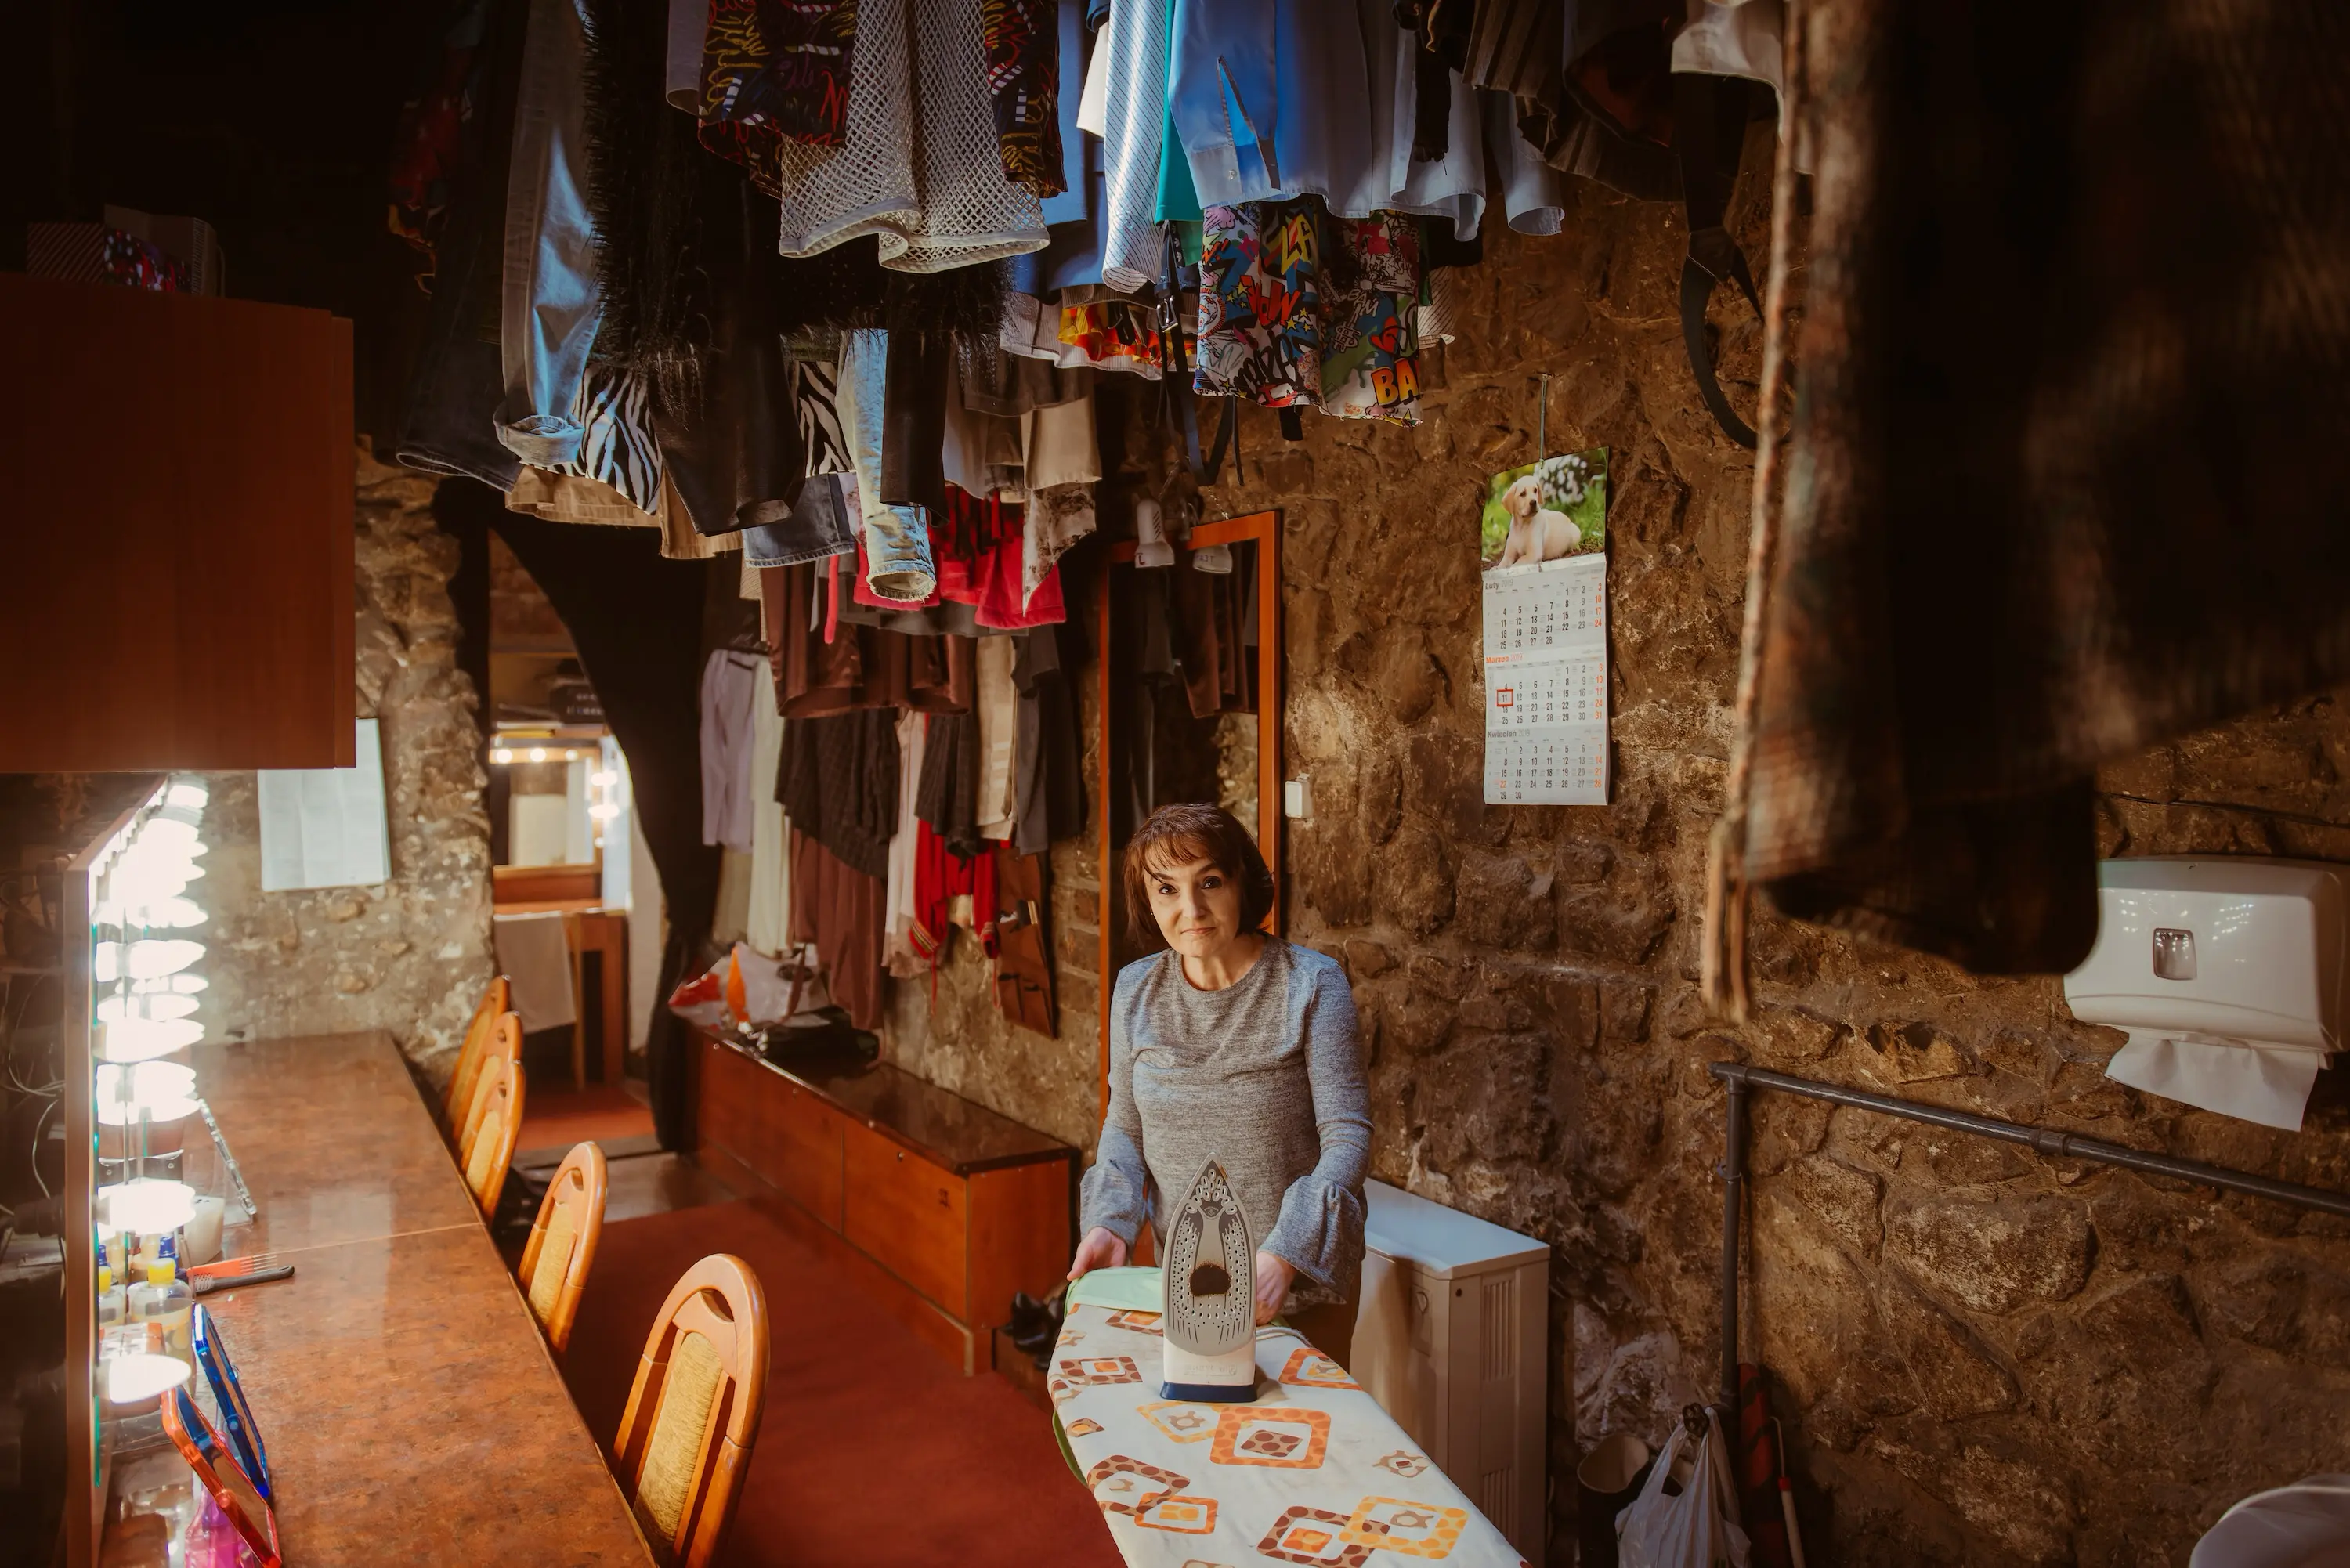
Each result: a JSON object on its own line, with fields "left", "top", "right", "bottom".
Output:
{"left": 1046, "top": 1270, "right": 1525, "bottom": 1568}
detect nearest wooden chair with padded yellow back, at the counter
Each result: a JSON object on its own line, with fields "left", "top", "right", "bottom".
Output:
{"left": 613, "top": 1253, "right": 766, "bottom": 1568}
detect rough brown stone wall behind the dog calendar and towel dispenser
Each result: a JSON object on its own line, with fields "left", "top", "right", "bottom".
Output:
{"left": 1184, "top": 177, "right": 2350, "bottom": 1566}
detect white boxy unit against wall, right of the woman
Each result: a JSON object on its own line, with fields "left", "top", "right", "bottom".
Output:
{"left": 1354, "top": 1183, "right": 1551, "bottom": 1568}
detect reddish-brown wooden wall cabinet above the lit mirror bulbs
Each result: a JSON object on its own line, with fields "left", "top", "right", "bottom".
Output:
{"left": 0, "top": 273, "right": 355, "bottom": 773}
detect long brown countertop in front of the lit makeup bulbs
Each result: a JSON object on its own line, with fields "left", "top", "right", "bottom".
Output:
{"left": 113, "top": 1035, "right": 653, "bottom": 1566}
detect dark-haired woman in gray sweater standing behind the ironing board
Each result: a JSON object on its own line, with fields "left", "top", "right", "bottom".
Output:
{"left": 1069, "top": 807, "right": 1370, "bottom": 1366}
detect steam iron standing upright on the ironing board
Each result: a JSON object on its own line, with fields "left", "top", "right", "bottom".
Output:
{"left": 1159, "top": 1159, "right": 1257, "bottom": 1406}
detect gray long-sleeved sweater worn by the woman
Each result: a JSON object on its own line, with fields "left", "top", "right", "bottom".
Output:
{"left": 1079, "top": 938, "right": 1370, "bottom": 1307}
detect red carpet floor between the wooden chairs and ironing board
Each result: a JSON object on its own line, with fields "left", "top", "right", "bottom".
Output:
{"left": 564, "top": 1199, "right": 1121, "bottom": 1568}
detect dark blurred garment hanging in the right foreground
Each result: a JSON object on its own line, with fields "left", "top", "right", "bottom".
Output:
{"left": 1732, "top": 0, "right": 2350, "bottom": 974}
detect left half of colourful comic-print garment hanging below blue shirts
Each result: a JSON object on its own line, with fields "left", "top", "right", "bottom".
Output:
{"left": 1191, "top": 197, "right": 1323, "bottom": 409}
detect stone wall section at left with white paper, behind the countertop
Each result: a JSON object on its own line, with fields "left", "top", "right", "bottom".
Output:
{"left": 193, "top": 444, "right": 491, "bottom": 1077}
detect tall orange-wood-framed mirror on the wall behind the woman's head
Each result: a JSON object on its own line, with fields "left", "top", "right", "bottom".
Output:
{"left": 1095, "top": 512, "right": 1281, "bottom": 1096}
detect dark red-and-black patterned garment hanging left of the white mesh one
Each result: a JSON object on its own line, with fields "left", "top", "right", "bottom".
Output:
{"left": 700, "top": 0, "right": 858, "bottom": 195}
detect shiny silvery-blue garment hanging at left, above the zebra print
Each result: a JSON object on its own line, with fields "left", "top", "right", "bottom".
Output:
{"left": 498, "top": 0, "right": 604, "bottom": 468}
